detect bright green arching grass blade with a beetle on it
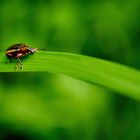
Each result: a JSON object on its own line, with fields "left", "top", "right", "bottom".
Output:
{"left": 0, "top": 51, "right": 140, "bottom": 100}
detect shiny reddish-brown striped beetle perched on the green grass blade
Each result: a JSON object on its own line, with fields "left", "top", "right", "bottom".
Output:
{"left": 5, "top": 43, "right": 38, "bottom": 69}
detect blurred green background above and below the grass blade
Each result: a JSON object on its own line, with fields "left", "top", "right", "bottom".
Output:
{"left": 0, "top": 0, "right": 140, "bottom": 140}
